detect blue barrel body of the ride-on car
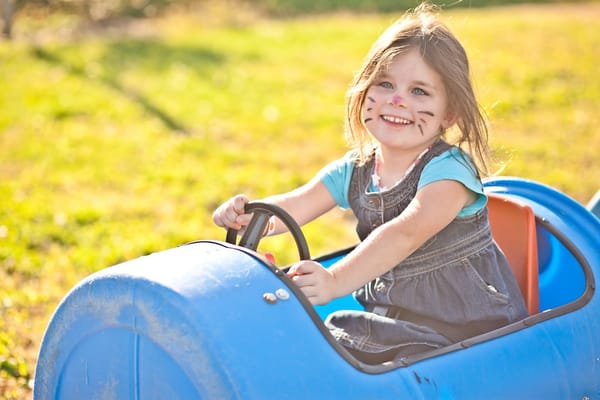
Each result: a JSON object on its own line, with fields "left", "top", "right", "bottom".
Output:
{"left": 34, "top": 178, "right": 600, "bottom": 400}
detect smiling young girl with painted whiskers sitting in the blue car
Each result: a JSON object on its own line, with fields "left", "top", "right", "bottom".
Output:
{"left": 213, "top": 5, "right": 527, "bottom": 363}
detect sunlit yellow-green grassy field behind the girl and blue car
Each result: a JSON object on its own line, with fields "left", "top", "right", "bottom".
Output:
{"left": 0, "top": 3, "right": 600, "bottom": 399}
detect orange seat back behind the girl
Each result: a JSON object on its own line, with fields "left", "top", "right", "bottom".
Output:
{"left": 488, "top": 193, "right": 540, "bottom": 315}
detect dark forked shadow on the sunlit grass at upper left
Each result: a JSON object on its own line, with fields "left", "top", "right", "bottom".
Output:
{"left": 32, "top": 41, "right": 224, "bottom": 134}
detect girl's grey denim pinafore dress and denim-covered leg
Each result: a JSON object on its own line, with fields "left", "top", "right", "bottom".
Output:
{"left": 325, "top": 140, "right": 527, "bottom": 363}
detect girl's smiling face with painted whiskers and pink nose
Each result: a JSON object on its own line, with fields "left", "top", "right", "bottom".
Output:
{"left": 363, "top": 49, "right": 454, "bottom": 151}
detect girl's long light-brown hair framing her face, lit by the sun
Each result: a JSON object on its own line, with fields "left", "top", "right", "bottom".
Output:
{"left": 345, "top": 3, "right": 489, "bottom": 175}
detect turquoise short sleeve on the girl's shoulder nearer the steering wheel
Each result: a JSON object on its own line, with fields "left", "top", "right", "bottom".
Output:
{"left": 317, "top": 152, "right": 355, "bottom": 209}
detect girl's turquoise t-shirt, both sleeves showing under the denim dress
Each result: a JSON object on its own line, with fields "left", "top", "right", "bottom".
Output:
{"left": 317, "top": 147, "right": 487, "bottom": 217}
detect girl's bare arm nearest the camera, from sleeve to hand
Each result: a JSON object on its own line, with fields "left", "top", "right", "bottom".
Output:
{"left": 288, "top": 180, "right": 475, "bottom": 304}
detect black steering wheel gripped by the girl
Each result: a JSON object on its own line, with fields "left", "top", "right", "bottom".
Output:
{"left": 225, "top": 201, "right": 310, "bottom": 260}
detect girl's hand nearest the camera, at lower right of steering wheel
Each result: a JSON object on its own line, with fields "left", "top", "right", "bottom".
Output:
{"left": 287, "top": 260, "right": 337, "bottom": 305}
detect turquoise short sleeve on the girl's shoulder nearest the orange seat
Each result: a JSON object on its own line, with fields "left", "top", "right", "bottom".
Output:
{"left": 417, "top": 147, "right": 487, "bottom": 217}
